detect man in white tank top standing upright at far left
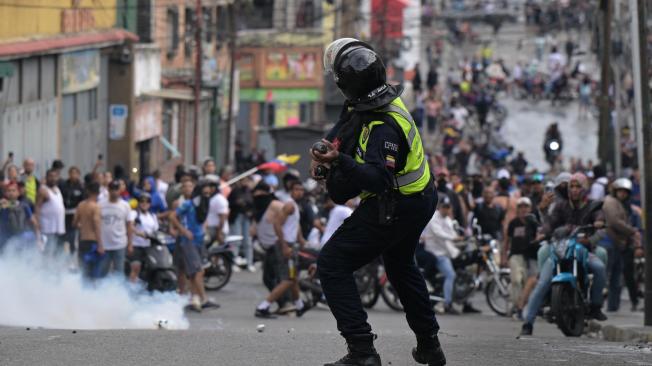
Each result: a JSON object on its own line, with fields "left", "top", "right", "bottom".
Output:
{"left": 35, "top": 169, "right": 66, "bottom": 255}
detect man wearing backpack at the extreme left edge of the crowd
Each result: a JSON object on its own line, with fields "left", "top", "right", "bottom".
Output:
{"left": 0, "top": 182, "right": 40, "bottom": 251}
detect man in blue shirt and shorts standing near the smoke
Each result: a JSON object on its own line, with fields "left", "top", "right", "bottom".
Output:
{"left": 170, "top": 180, "right": 219, "bottom": 311}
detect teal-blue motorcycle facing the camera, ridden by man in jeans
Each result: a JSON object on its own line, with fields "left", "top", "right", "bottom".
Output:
{"left": 550, "top": 225, "right": 594, "bottom": 337}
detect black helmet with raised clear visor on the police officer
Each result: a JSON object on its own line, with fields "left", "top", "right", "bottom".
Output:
{"left": 324, "top": 38, "right": 396, "bottom": 105}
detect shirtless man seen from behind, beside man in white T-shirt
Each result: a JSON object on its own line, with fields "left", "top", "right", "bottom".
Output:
{"left": 72, "top": 182, "right": 104, "bottom": 278}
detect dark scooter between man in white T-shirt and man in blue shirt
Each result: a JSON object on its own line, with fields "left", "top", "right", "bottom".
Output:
{"left": 125, "top": 231, "right": 178, "bottom": 292}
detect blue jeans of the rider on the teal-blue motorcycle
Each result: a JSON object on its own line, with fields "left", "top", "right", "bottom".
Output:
{"left": 525, "top": 254, "right": 607, "bottom": 324}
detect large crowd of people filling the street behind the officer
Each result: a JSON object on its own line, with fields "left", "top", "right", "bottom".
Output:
{"left": 0, "top": 2, "right": 643, "bottom": 335}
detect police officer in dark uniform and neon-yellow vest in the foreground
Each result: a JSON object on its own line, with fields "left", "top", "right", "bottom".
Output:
{"left": 311, "top": 38, "right": 446, "bottom": 366}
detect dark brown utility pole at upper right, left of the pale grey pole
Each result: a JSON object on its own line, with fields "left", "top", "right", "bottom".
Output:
{"left": 598, "top": 0, "right": 612, "bottom": 166}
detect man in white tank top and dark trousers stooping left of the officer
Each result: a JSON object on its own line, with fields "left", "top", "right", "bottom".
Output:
{"left": 255, "top": 181, "right": 308, "bottom": 318}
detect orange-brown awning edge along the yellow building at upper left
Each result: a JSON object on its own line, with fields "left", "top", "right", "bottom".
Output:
{"left": 0, "top": 29, "right": 138, "bottom": 60}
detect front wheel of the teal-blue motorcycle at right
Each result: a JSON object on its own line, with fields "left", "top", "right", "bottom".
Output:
{"left": 550, "top": 283, "right": 584, "bottom": 337}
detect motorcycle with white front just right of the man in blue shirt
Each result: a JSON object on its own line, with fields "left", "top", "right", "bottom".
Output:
{"left": 204, "top": 235, "right": 242, "bottom": 291}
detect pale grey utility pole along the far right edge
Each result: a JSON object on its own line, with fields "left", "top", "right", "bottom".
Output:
{"left": 630, "top": 0, "right": 652, "bottom": 326}
